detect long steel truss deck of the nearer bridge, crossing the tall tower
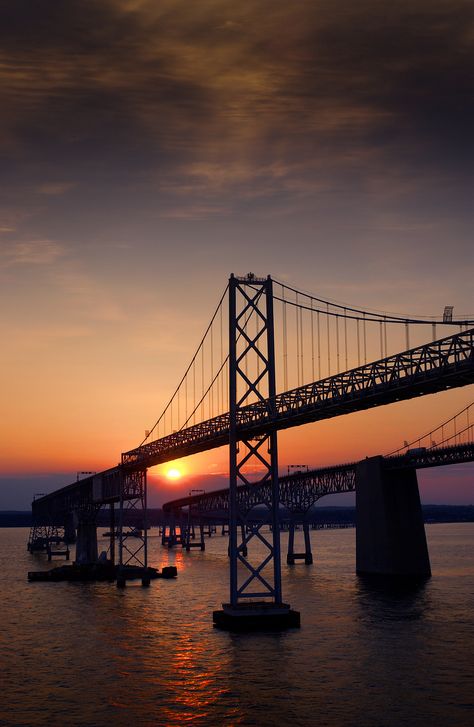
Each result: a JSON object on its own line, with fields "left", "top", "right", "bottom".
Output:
{"left": 122, "top": 328, "right": 474, "bottom": 469}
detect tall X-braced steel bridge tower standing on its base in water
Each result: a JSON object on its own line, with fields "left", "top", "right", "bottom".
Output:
{"left": 214, "top": 273, "right": 300, "bottom": 630}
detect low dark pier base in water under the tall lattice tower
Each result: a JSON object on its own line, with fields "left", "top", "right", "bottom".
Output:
{"left": 212, "top": 601, "right": 300, "bottom": 631}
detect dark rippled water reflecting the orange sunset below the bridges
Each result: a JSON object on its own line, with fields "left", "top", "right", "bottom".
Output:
{"left": 0, "top": 523, "right": 474, "bottom": 727}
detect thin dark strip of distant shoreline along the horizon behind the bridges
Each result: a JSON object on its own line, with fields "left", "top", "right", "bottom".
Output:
{"left": 0, "top": 505, "right": 474, "bottom": 528}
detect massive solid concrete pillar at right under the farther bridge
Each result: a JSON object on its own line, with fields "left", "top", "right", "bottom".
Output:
{"left": 356, "top": 457, "right": 431, "bottom": 578}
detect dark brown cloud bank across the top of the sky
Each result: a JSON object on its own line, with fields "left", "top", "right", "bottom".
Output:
{"left": 0, "top": 0, "right": 474, "bottom": 219}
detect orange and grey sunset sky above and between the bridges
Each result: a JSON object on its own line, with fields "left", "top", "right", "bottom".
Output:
{"left": 0, "top": 0, "right": 474, "bottom": 509}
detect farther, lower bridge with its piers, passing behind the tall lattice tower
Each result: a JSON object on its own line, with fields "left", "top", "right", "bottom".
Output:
{"left": 162, "top": 442, "right": 474, "bottom": 575}
